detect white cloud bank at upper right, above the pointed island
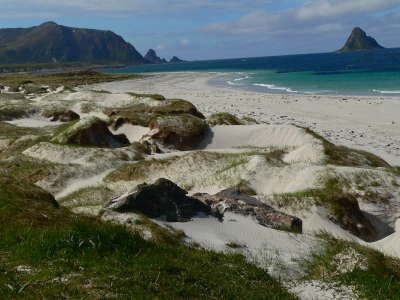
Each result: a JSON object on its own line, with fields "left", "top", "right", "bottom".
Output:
{"left": 199, "top": 0, "right": 400, "bottom": 36}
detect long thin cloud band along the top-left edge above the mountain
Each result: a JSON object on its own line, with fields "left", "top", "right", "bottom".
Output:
{"left": 0, "top": 0, "right": 278, "bottom": 18}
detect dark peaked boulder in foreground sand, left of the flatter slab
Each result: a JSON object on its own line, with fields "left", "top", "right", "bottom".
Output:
{"left": 103, "top": 178, "right": 211, "bottom": 222}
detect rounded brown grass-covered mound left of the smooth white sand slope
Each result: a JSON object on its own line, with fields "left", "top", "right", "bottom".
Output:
{"left": 140, "top": 114, "right": 206, "bottom": 152}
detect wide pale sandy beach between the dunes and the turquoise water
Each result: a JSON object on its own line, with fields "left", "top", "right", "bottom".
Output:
{"left": 81, "top": 72, "right": 400, "bottom": 165}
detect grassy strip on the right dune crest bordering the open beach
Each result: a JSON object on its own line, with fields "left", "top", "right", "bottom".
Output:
{"left": 300, "top": 127, "right": 390, "bottom": 167}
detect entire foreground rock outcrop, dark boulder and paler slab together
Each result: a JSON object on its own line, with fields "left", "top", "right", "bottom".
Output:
{"left": 103, "top": 178, "right": 302, "bottom": 232}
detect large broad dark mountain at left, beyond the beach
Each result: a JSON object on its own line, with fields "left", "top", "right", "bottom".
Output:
{"left": 0, "top": 22, "right": 148, "bottom": 65}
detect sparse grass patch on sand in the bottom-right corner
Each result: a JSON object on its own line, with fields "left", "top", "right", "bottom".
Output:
{"left": 305, "top": 232, "right": 400, "bottom": 300}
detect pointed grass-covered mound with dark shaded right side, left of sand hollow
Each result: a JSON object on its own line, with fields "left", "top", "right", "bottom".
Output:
{"left": 51, "top": 117, "right": 130, "bottom": 148}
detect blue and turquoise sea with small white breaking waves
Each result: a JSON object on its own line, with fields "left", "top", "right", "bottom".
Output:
{"left": 100, "top": 48, "right": 400, "bottom": 97}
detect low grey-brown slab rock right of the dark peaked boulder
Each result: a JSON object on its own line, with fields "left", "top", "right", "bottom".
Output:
{"left": 193, "top": 189, "right": 303, "bottom": 232}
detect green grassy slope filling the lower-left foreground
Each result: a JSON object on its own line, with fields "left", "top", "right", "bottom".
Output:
{"left": 0, "top": 174, "right": 296, "bottom": 299}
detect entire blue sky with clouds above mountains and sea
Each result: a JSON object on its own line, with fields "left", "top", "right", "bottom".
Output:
{"left": 0, "top": 0, "right": 400, "bottom": 60}
